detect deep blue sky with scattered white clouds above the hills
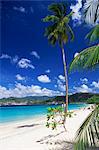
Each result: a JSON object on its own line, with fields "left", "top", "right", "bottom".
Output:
{"left": 0, "top": 0, "right": 99, "bottom": 98}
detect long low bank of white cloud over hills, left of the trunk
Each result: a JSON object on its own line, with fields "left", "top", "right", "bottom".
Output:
{"left": 0, "top": 83, "right": 63, "bottom": 98}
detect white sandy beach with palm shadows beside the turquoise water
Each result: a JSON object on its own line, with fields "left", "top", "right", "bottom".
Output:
{"left": 0, "top": 108, "right": 91, "bottom": 150}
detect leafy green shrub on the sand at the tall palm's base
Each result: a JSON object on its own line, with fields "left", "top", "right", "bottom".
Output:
{"left": 46, "top": 106, "right": 73, "bottom": 130}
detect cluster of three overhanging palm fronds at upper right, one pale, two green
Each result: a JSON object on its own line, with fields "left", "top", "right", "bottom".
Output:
{"left": 70, "top": 0, "right": 99, "bottom": 72}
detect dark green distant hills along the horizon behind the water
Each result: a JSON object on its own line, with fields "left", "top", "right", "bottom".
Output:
{"left": 0, "top": 93, "right": 99, "bottom": 106}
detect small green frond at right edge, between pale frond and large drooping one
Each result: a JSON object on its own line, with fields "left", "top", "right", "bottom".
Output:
{"left": 85, "top": 24, "right": 99, "bottom": 42}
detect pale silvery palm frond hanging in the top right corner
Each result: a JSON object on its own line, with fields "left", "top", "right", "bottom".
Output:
{"left": 83, "top": 0, "right": 99, "bottom": 25}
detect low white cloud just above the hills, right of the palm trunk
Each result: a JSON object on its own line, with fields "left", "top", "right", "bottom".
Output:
{"left": 73, "top": 84, "right": 93, "bottom": 93}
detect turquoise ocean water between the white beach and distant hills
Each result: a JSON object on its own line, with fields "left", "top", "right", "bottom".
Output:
{"left": 0, "top": 104, "right": 86, "bottom": 123}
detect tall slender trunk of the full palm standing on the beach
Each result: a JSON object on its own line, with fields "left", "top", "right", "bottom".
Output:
{"left": 61, "top": 46, "right": 68, "bottom": 123}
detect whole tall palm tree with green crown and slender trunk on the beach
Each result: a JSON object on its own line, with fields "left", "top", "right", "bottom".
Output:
{"left": 43, "top": 3, "right": 74, "bottom": 122}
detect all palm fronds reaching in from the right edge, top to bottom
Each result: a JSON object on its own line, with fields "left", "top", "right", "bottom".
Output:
{"left": 69, "top": 0, "right": 99, "bottom": 150}
